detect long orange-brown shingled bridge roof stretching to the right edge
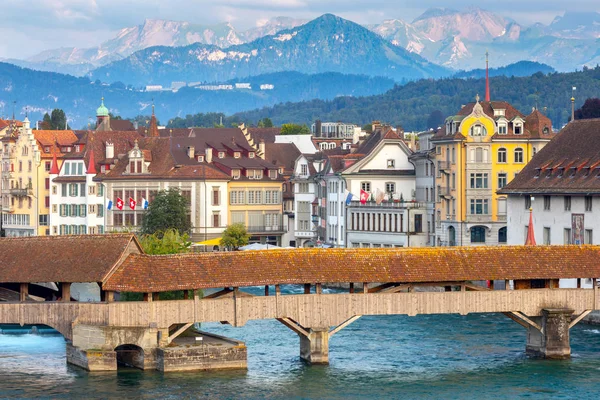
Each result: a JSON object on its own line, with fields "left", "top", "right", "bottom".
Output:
{"left": 103, "top": 246, "right": 600, "bottom": 292}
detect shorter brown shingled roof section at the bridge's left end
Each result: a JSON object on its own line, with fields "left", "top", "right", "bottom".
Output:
{"left": 0, "top": 234, "right": 141, "bottom": 283}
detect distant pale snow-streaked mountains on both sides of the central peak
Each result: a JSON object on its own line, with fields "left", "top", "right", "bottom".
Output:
{"left": 5, "top": 8, "right": 600, "bottom": 80}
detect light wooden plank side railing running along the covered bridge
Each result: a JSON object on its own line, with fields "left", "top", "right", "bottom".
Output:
{"left": 0, "top": 288, "right": 600, "bottom": 338}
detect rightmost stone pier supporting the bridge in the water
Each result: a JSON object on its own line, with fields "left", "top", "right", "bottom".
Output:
{"left": 526, "top": 308, "right": 573, "bottom": 360}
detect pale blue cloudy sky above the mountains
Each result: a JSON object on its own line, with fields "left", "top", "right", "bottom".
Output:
{"left": 0, "top": 0, "right": 600, "bottom": 59}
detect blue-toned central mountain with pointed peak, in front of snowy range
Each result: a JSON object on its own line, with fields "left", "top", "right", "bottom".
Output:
{"left": 90, "top": 14, "right": 450, "bottom": 86}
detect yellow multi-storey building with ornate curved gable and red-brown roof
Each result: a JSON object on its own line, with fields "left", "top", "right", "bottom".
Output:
{"left": 432, "top": 96, "right": 554, "bottom": 246}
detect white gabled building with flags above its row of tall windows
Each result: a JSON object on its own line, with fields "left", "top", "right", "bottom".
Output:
{"left": 341, "top": 126, "right": 428, "bottom": 247}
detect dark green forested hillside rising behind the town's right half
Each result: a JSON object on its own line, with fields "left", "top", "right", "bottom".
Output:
{"left": 233, "top": 66, "right": 600, "bottom": 130}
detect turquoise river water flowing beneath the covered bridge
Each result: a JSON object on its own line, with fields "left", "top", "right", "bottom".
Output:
{"left": 0, "top": 314, "right": 600, "bottom": 400}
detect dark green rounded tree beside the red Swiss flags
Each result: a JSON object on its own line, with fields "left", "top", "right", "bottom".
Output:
{"left": 142, "top": 188, "right": 192, "bottom": 239}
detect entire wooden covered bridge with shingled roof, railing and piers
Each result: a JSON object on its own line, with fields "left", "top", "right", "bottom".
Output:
{"left": 0, "top": 234, "right": 600, "bottom": 370}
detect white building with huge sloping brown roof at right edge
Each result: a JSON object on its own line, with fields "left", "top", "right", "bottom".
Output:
{"left": 499, "top": 119, "right": 600, "bottom": 287}
